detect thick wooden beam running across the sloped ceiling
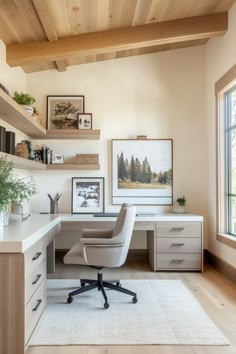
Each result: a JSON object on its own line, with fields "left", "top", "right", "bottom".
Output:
{"left": 6, "top": 12, "right": 228, "bottom": 66}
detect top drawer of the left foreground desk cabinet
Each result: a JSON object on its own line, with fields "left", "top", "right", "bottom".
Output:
{"left": 25, "top": 240, "right": 46, "bottom": 279}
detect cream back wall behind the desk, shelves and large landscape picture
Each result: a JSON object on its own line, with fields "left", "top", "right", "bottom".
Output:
{"left": 27, "top": 46, "right": 208, "bottom": 248}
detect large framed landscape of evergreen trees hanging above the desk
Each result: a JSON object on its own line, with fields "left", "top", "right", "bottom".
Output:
{"left": 112, "top": 139, "right": 173, "bottom": 205}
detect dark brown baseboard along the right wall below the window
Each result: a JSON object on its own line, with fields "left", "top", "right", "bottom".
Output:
{"left": 204, "top": 250, "right": 236, "bottom": 283}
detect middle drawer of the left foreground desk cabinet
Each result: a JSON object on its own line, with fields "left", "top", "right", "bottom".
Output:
{"left": 25, "top": 258, "right": 46, "bottom": 304}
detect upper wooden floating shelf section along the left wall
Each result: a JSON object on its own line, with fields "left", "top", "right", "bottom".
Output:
{"left": 0, "top": 89, "right": 46, "bottom": 139}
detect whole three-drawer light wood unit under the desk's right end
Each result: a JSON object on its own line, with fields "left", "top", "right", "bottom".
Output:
{"left": 153, "top": 221, "right": 202, "bottom": 270}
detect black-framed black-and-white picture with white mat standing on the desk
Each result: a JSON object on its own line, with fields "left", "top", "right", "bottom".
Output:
{"left": 71, "top": 177, "right": 104, "bottom": 214}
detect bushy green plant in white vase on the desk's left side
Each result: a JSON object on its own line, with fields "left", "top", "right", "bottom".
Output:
{"left": 0, "top": 157, "right": 37, "bottom": 229}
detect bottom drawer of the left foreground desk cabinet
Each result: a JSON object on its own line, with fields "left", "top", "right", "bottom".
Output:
{"left": 25, "top": 281, "right": 46, "bottom": 344}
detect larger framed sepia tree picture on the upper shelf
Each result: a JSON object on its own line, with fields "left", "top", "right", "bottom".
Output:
{"left": 47, "top": 96, "right": 85, "bottom": 129}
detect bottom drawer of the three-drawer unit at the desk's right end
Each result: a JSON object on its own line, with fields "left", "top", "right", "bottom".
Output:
{"left": 156, "top": 253, "right": 202, "bottom": 270}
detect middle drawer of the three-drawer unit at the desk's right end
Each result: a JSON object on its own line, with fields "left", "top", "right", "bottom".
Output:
{"left": 156, "top": 237, "right": 202, "bottom": 253}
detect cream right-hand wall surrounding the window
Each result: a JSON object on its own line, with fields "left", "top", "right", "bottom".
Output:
{"left": 206, "top": 4, "right": 236, "bottom": 267}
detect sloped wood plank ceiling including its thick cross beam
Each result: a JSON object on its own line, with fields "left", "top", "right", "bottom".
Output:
{"left": 0, "top": 0, "right": 235, "bottom": 73}
